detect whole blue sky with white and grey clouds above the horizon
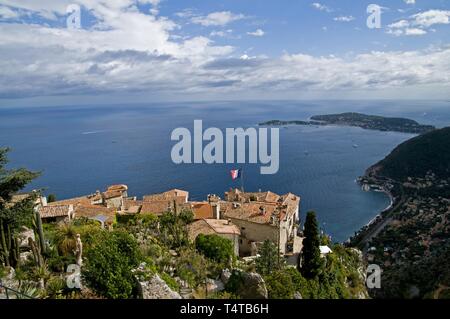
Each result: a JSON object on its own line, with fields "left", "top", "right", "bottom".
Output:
{"left": 0, "top": 0, "right": 450, "bottom": 107}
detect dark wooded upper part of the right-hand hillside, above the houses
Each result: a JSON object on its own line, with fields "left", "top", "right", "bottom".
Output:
{"left": 372, "top": 127, "right": 450, "bottom": 181}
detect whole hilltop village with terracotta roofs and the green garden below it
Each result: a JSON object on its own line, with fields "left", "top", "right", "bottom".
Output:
{"left": 0, "top": 149, "right": 367, "bottom": 299}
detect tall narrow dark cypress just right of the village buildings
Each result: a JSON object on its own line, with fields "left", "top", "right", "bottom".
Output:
{"left": 301, "top": 212, "right": 322, "bottom": 279}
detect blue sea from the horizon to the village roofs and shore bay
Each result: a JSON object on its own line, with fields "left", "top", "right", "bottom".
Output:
{"left": 0, "top": 101, "right": 450, "bottom": 241}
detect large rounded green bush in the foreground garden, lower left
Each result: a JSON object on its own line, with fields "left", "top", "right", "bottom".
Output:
{"left": 82, "top": 231, "right": 140, "bottom": 299}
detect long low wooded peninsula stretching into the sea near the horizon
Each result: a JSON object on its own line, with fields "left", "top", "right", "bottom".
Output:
{"left": 259, "top": 113, "right": 435, "bottom": 134}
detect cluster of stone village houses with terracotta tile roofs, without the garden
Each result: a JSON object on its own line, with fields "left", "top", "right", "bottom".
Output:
{"left": 37, "top": 185, "right": 303, "bottom": 262}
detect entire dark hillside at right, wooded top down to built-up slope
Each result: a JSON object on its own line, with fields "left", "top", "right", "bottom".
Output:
{"left": 358, "top": 128, "right": 450, "bottom": 298}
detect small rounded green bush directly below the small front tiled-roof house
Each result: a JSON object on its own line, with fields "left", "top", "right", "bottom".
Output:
{"left": 195, "top": 234, "right": 234, "bottom": 263}
